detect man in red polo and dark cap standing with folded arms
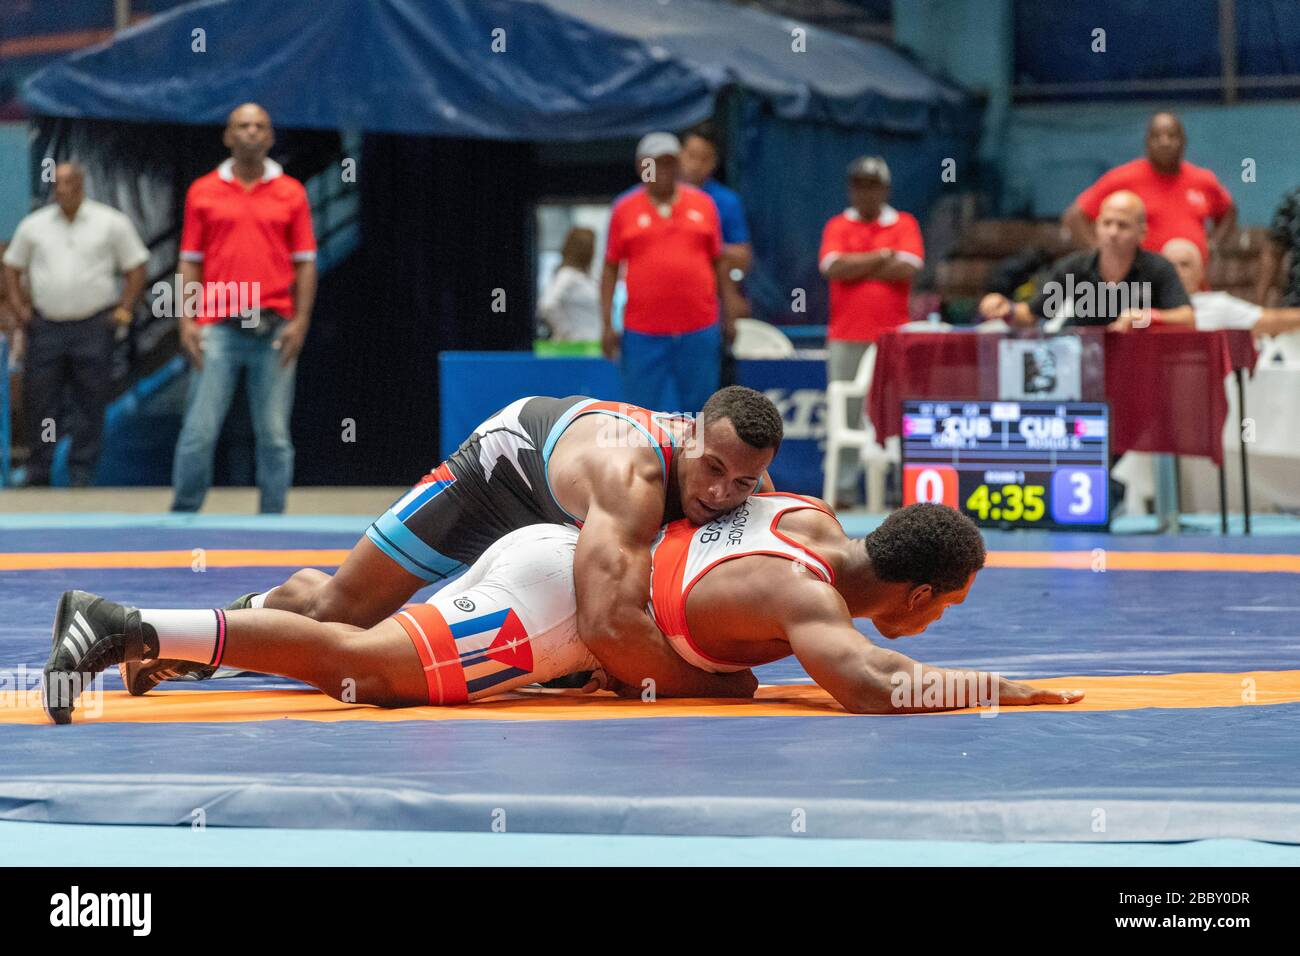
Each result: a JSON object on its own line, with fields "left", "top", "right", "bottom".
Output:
{"left": 819, "top": 156, "right": 926, "bottom": 507}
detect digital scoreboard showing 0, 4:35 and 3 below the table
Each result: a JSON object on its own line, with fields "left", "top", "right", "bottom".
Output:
{"left": 901, "top": 401, "right": 1110, "bottom": 529}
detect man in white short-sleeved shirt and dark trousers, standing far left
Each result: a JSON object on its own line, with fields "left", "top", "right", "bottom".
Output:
{"left": 4, "top": 163, "right": 150, "bottom": 485}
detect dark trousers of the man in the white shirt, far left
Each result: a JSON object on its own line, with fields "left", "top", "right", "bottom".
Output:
{"left": 22, "top": 308, "right": 113, "bottom": 484}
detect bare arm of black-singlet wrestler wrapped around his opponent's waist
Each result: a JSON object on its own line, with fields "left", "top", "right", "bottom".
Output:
{"left": 573, "top": 467, "right": 758, "bottom": 697}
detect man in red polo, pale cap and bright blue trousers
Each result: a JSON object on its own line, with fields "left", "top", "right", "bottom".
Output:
{"left": 601, "top": 133, "right": 742, "bottom": 411}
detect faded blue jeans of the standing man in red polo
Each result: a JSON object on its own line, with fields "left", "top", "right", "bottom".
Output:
{"left": 172, "top": 316, "right": 298, "bottom": 514}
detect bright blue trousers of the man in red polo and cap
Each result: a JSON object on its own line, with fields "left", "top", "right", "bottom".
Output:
{"left": 621, "top": 323, "right": 723, "bottom": 414}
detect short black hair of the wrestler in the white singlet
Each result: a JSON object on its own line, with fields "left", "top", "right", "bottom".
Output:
{"left": 866, "top": 503, "right": 985, "bottom": 593}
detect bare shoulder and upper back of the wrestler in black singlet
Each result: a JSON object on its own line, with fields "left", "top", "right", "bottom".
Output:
{"left": 546, "top": 415, "right": 667, "bottom": 520}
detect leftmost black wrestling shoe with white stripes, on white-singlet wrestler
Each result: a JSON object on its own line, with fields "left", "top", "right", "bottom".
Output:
{"left": 40, "top": 591, "right": 146, "bottom": 723}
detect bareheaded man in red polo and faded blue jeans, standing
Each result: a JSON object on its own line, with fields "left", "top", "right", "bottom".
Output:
{"left": 172, "top": 103, "right": 316, "bottom": 514}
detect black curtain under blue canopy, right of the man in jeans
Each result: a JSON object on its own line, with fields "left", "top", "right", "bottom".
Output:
{"left": 294, "top": 135, "right": 534, "bottom": 485}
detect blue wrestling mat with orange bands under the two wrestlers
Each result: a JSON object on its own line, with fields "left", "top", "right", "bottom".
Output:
{"left": 0, "top": 519, "right": 1300, "bottom": 864}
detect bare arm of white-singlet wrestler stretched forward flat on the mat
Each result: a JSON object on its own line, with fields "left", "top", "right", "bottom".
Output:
{"left": 784, "top": 587, "right": 1083, "bottom": 714}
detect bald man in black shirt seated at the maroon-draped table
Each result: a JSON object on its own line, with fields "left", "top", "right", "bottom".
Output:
{"left": 979, "top": 190, "right": 1192, "bottom": 332}
